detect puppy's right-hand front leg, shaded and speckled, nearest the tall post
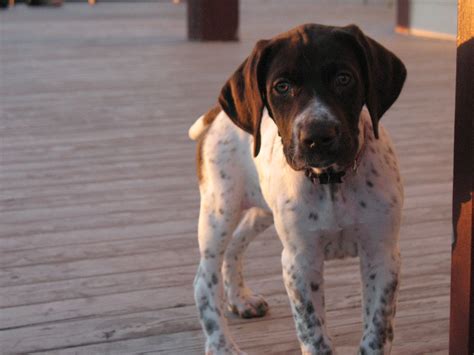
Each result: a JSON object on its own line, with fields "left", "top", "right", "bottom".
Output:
{"left": 359, "top": 239, "right": 400, "bottom": 355}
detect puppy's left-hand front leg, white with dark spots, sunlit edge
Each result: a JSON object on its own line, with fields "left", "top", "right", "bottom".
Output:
{"left": 275, "top": 214, "right": 334, "bottom": 354}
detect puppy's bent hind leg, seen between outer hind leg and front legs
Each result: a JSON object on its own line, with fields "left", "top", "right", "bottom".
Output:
{"left": 222, "top": 207, "right": 273, "bottom": 318}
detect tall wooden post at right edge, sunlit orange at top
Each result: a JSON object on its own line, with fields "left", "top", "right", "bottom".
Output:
{"left": 449, "top": 0, "right": 474, "bottom": 355}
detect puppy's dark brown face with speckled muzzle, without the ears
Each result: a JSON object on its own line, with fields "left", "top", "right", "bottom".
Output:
{"left": 265, "top": 25, "right": 365, "bottom": 170}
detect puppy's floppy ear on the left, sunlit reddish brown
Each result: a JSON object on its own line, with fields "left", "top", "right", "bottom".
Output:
{"left": 219, "top": 40, "right": 269, "bottom": 156}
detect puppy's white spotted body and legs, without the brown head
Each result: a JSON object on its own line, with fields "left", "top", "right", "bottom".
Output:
{"left": 191, "top": 110, "right": 403, "bottom": 354}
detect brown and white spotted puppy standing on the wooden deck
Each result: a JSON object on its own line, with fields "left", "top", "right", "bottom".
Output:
{"left": 189, "top": 24, "right": 406, "bottom": 354}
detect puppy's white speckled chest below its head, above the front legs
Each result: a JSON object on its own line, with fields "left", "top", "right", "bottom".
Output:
{"left": 255, "top": 114, "right": 403, "bottom": 259}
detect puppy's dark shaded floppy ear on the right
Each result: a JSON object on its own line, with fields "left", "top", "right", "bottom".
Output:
{"left": 342, "top": 25, "right": 407, "bottom": 138}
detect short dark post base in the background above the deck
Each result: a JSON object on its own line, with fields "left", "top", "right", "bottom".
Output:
{"left": 188, "top": 0, "right": 239, "bottom": 41}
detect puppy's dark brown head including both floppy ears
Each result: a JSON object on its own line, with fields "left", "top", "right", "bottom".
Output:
{"left": 219, "top": 24, "right": 406, "bottom": 170}
